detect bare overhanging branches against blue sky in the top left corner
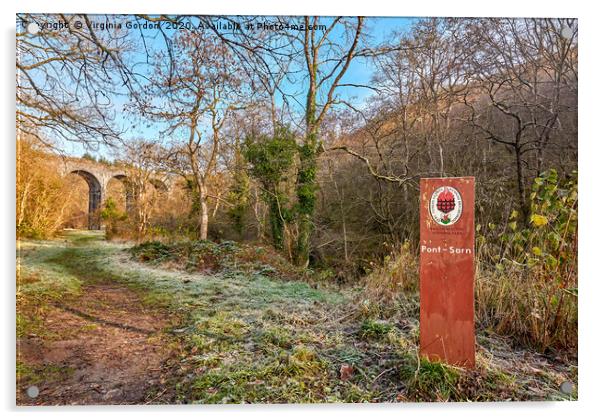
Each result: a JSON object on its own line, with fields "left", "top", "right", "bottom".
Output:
{"left": 16, "top": 14, "right": 145, "bottom": 147}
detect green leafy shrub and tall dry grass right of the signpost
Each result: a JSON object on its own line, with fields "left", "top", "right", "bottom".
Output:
{"left": 476, "top": 170, "right": 577, "bottom": 351}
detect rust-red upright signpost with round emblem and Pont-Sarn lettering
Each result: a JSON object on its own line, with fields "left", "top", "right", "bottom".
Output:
{"left": 420, "top": 177, "right": 475, "bottom": 368}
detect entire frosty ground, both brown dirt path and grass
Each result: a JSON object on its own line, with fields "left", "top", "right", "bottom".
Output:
{"left": 17, "top": 231, "right": 577, "bottom": 405}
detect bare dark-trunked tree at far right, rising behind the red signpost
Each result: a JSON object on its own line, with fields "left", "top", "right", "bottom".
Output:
{"left": 465, "top": 19, "right": 577, "bottom": 220}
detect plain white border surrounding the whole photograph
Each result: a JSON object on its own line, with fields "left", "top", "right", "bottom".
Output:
{"left": 0, "top": 0, "right": 602, "bottom": 420}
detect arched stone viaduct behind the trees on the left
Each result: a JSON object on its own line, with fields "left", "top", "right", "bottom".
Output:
{"left": 59, "top": 158, "right": 172, "bottom": 230}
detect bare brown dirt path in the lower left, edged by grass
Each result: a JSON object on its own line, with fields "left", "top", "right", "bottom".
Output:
{"left": 17, "top": 283, "right": 175, "bottom": 405}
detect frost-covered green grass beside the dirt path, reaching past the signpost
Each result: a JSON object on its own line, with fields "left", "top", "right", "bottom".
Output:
{"left": 15, "top": 232, "right": 576, "bottom": 403}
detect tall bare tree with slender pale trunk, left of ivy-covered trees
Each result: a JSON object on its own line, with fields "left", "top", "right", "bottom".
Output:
{"left": 141, "top": 32, "right": 242, "bottom": 239}
